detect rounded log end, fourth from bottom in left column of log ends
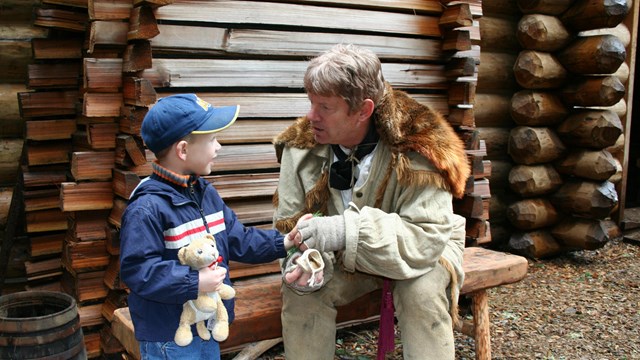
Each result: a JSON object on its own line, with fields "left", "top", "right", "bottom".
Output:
{"left": 507, "top": 126, "right": 565, "bottom": 165}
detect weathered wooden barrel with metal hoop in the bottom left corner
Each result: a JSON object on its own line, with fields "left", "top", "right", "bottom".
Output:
{"left": 0, "top": 291, "right": 87, "bottom": 360}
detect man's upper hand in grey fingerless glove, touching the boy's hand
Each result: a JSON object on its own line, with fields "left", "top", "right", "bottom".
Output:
{"left": 294, "top": 215, "right": 346, "bottom": 252}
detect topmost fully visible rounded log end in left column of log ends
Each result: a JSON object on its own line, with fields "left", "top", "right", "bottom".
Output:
{"left": 516, "top": 14, "right": 573, "bottom": 52}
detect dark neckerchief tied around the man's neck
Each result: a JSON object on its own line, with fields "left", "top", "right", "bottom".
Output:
{"left": 329, "top": 119, "right": 380, "bottom": 190}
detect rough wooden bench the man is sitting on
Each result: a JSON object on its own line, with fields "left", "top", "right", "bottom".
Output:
{"left": 112, "top": 247, "right": 528, "bottom": 360}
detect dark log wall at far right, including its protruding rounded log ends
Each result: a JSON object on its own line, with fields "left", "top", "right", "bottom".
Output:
{"left": 476, "top": 0, "right": 637, "bottom": 258}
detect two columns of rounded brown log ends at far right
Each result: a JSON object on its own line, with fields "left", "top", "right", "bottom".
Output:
{"left": 506, "top": 0, "right": 629, "bottom": 258}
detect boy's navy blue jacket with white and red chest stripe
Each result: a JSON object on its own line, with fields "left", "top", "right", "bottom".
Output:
{"left": 120, "top": 173, "right": 286, "bottom": 342}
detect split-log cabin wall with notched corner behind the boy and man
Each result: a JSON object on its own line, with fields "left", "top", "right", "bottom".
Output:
{"left": 13, "top": 0, "right": 484, "bottom": 357}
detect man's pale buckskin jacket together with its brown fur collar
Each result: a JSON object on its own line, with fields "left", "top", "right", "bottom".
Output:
{"left": 274, "top": 84, "right": 470, "bottom": 303}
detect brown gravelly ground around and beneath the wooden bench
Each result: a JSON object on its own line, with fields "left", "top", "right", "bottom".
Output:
{"left": 227, "top": 239, "right": 640, "bottom": 360}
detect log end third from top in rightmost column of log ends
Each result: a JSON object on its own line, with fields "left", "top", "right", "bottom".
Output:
{"left": 562, "top": 76, "right": 626, "bottom": 106}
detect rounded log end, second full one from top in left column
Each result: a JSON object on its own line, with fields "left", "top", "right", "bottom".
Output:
{"left": 513, "top": 50, "right": 567, "bottom": 89}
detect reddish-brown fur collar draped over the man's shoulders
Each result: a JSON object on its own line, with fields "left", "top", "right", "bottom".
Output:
{"left": 274, "top": 84, "right": 471, "bottom": 198}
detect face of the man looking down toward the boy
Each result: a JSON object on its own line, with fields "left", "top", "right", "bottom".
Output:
{"left": 307, "top": 94, "right": 361, "bottom": 147}
